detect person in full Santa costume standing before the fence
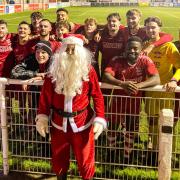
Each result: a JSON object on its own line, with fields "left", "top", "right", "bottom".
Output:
{"left": 36, "top": 35, "right": 107, "bottom": 180}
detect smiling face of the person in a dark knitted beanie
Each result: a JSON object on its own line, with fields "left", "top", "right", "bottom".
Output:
{"left": 35, "top": 48, "right": 49, "bottom": 64}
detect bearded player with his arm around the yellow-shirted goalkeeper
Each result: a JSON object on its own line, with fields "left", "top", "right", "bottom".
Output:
{"left": 122, "top": 9, "right": 173, "bottom": 54}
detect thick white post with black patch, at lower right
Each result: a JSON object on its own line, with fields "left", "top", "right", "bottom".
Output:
{"left": 158, "top": 109, "right": 174, "bottom": 180}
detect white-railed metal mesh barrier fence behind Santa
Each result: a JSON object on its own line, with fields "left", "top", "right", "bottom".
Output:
{"left": 0, "top": 78, "right": 180, "bottom": 179}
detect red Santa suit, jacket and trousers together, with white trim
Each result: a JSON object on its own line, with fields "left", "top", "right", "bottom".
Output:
{"left": 37, "top": 67, "right": 106, "bottom": 179}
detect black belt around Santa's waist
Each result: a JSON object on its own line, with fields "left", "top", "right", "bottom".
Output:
{"left": 52, "top": 107, "right": 86, "bottom": 118}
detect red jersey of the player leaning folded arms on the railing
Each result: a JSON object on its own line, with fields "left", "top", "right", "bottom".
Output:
{"left": 105, "top": 56, "right": 158, "bottom": 115}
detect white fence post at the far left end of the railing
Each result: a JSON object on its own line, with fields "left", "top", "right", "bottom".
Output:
{"left": 0, "top": 83, "right": 9, "bottom": 175}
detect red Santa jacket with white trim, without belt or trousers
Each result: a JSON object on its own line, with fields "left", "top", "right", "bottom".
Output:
{"left": 38, "top": 67, "right": 106, "bottom": 132}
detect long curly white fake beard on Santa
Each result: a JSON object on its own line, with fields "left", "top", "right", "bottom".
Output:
{"left": 51, "top": 48, "right": 89, "bottom": 97}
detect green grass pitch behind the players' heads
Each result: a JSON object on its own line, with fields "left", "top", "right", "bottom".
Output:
{"left": 1, "top": 7, "right": 180, "bottom": 40}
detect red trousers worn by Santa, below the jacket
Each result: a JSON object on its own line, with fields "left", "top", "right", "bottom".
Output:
{"left": 51, "top": 125, "right": 95, "bottom": 180}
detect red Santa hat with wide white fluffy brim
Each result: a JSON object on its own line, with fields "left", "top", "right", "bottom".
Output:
{"left": 62, "top": 34, "right": 83, "bottom": 46}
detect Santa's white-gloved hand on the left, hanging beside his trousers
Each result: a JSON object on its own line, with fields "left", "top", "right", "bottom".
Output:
{"left": 35, "top": 114, "right": 49, "bottom": 138}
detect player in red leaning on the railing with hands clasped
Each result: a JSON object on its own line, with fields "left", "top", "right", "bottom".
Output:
{"left": 103, "top": 36, "right": 160, "bottom": 159}
